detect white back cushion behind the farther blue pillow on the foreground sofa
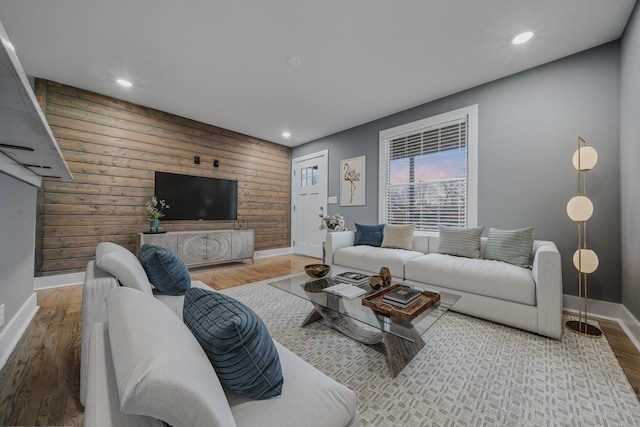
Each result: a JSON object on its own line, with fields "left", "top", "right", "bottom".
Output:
{"left": 96, "top": 242, "right": 153, "bottom": 295}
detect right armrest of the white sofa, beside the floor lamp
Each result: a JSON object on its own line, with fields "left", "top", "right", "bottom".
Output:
{"left": 531, "top": 241, "right": 562, "bottom": 339}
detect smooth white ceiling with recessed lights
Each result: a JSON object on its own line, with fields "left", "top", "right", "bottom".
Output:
{"left": 0, "top": 0, "right": 635, "bottom": 146}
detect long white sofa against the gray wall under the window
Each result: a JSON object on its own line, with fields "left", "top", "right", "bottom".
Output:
{"left": 325, "top": 231, "right": 562, "bottom": 339}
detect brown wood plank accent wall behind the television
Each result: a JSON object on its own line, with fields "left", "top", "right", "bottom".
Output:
{"left": 36, "top": 80, "right": 291, "bottom": 275}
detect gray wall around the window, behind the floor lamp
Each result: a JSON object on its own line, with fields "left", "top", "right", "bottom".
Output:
{"left": 293, "top": 42, "right": 622, "bottom": 302}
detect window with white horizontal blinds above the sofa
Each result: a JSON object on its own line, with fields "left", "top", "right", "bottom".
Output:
{"left": 380, "top": 108, "right": 476, "bottom": 231}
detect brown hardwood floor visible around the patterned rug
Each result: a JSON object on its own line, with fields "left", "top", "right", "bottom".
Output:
{"left": 0, "top": 255, "right": 640, "bottom": 426}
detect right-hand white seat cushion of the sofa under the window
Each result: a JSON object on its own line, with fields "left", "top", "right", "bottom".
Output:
{"left": 405, "top": 253, "right": 536, "bottom": 305}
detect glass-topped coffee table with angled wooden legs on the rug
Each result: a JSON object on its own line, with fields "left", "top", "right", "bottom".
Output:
{"left": 269, "top": 268, "right": 460, "bottom": 377}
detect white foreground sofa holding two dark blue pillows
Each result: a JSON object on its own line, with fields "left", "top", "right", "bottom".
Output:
{"left": 80, "top": 244, "right": 359, "bottom": 427}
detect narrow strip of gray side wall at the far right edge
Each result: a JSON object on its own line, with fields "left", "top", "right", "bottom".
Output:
{"left": 620, "top": 4, "right": 640, "bottom": 319}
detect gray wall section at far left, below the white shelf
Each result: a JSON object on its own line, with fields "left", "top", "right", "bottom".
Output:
{"left": 0, "top": 173, "right": 37, "bottom": 330}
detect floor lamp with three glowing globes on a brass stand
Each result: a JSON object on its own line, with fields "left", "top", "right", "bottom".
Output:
{"left": 565, "top": 136, "right": 602, "bottom": 338}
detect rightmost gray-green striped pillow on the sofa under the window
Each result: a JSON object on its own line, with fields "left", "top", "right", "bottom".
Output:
{"left": 484, "top": 227, "right": 533, "bottom": 267}
